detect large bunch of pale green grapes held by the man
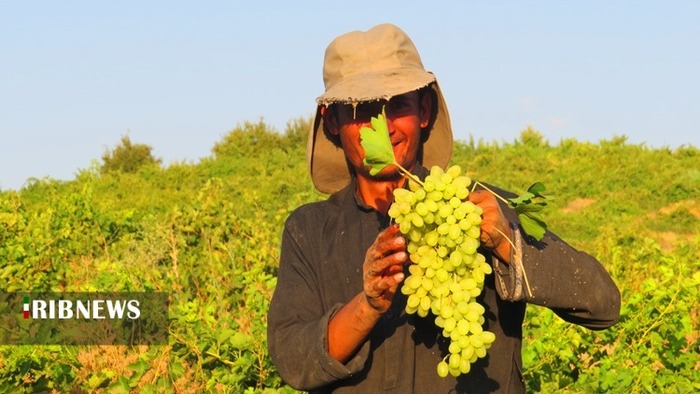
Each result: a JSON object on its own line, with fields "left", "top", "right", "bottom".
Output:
{"left": 389, "top": 166, "right": 496, "bottom": 377}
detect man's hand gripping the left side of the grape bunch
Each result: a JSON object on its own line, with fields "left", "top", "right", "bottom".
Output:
{"left": 362, "top": 225, "right": 408, "bottom": 313}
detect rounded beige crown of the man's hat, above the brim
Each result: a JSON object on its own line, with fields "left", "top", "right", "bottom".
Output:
{"left": 323, "top": 24, "right": 425, "bottom": 94}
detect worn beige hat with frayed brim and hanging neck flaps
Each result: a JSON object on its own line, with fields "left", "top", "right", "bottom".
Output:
{"left": 306, "top": 24, "right": 453, "bottom": 194}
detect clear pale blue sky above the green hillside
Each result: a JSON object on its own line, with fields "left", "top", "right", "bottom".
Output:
{"left": 0, "top": 0, "right": 700, "bottom": 190}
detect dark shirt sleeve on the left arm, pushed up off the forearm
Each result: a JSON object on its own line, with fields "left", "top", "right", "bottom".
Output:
{"left": 267, "top": 214, "right": 370, "bottom": 390}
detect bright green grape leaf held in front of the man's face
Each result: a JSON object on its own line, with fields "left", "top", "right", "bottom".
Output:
{"left": 360, "top": 108, "right": 396, "bottom": 176}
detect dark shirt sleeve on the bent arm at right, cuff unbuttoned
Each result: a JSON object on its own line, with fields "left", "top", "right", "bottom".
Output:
{"left": 491, "top": 192, "right": 620, "bottom": 330}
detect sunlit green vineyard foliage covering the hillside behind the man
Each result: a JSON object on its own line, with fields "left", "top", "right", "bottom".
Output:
{"left": 0, "top": 119, "right": 700, "bottom": 393}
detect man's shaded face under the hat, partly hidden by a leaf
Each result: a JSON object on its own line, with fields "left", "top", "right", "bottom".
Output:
{"left": 324, "top": 91, "right": 432, "bottom": 179}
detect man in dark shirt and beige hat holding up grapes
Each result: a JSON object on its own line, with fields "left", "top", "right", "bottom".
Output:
{"left": 268, "top": 24, "right": 620, "bottom": 393}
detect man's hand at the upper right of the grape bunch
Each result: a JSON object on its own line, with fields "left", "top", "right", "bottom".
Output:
{"left": 469, "top": 190, "right": 511, "bottom": 263}
